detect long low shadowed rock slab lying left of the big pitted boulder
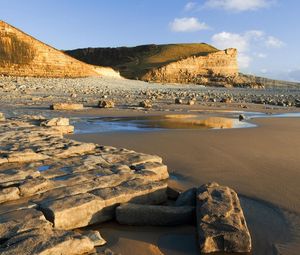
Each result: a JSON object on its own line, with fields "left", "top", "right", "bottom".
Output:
{"left": 116, "top": 203, "right": 195, "bottom": 226}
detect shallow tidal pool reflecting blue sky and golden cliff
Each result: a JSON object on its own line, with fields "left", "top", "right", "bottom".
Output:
{"left": 72, "top": 114, "right": 255, "bottom": 134}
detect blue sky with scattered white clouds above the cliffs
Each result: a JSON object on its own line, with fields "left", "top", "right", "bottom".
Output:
{"left": 0, "top": 0, "right": 300, "bottom": 81}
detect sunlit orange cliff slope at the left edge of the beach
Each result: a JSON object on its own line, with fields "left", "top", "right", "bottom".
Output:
{"left": 0, "top": 21, "right": 99, "bottom": 77}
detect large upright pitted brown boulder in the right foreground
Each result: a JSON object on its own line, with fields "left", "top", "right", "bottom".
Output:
{"left": 196, "top": 183, "right": 251, "bottom": 253}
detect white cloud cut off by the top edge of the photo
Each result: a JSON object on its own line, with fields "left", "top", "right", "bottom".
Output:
{"left": 204, "top": 0, "right": 274, "bottom": 12}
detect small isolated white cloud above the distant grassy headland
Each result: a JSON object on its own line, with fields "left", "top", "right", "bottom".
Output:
{"left": 170, "top": 17, "right": 209, "bottom": 32}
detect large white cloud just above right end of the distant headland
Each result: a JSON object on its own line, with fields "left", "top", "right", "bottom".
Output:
{"left": 211, "top": 30, "right": 283, "bottom": 69}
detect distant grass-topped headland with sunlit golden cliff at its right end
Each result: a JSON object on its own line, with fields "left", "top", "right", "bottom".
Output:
{"left": 66, "top": 43, "right": 238, "bottom": 86}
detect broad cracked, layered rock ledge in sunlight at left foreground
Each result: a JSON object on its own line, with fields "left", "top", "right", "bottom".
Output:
{"left": 0, "top": 118, "right": 168, "bottom": 255}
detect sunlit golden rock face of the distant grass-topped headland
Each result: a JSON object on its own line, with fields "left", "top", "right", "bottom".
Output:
{"left": 140, "top": 49, "right": 238, "bottom": 85}
